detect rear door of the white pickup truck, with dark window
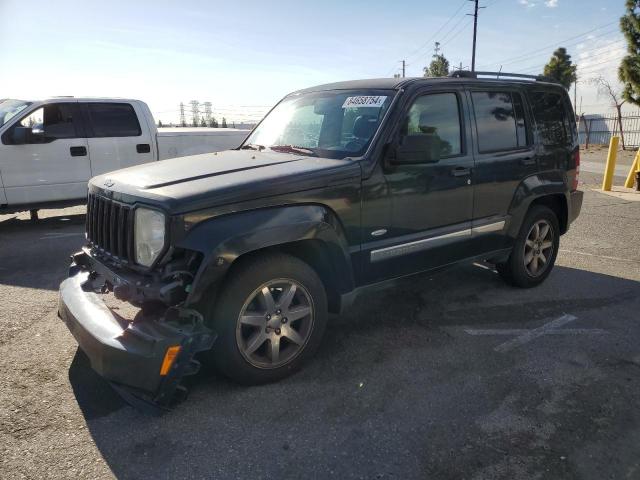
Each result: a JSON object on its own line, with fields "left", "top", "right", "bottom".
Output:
{"left": 80, "top": 102, "right": 155, "bottom": 176}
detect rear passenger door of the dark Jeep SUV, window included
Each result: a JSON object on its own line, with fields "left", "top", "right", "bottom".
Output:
{"left": 469, "top": 87, "right": 538, "bottom": 254}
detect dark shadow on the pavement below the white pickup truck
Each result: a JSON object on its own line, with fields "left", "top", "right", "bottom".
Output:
{"left": 0, "top": 214, "right": 85, "bottom": 290}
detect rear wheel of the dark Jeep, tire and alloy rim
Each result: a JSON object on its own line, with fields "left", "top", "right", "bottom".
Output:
{"left": 496, "top": 205, "right": 560, "bottom": 288}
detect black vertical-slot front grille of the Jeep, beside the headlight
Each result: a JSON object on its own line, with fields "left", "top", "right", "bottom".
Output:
{"left": 86, "top": 194, "right": 133, "bottom": 262}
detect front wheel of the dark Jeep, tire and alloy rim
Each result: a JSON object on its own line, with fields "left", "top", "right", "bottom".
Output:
{"left": 205, "top": 253, "right": 328, "bottom": 385}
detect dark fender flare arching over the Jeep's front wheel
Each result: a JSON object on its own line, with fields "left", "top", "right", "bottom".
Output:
{"left": 176, "top": 204, "right": 355, "bottom": 305}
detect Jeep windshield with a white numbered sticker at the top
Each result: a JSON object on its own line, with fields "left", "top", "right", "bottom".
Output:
{"left": 242, "top": 90, "right": 395, "bottom": 159}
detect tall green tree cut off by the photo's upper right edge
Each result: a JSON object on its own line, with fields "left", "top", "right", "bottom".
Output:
{"left": 618, "top": 0, "right": 640, "bottom": 105}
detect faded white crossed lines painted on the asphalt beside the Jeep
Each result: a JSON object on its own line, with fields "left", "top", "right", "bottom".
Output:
{"left": 465, "top": 314, "right": 607, "bottom": 353}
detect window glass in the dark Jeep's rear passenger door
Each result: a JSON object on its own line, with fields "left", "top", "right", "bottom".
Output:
{"left": 471, "top": 91, "right": 528, "bottom": 153}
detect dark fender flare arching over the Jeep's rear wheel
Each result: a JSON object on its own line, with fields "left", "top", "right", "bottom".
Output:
{"left": 507, "top": 170, "right": 569, "bottom": 238}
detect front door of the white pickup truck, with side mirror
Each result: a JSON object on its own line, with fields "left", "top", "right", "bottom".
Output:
{"left": 0, "top": 101, "right": 91, "bottom": 205}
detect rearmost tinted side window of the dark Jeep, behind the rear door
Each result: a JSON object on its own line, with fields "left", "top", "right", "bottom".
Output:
{"left": 529, "top": 92, "right": 571, "bottom": 146}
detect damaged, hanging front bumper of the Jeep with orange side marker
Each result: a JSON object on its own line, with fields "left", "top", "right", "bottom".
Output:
{"left": 58, "top": 252, "right": 215, "bottom": 409}
